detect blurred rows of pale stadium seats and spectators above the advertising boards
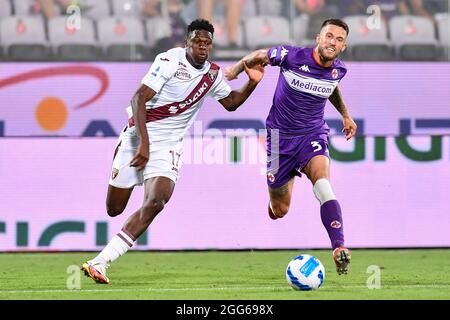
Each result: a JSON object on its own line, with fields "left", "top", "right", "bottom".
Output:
{"left": 0, "top": 0, "right": 450, "bottom": 61}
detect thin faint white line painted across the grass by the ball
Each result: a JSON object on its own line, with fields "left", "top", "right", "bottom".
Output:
{"left": 0, "top": 284, "right": 450, "bottom": 294}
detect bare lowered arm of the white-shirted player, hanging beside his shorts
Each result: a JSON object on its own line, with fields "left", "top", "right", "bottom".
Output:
{"left": 130, "top": 85, "right": 156, "bottom": 170}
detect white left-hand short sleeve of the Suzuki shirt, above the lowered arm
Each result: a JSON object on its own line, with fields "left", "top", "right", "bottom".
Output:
{"left": 141, "top": 52, "right": 178, "bottom": 92}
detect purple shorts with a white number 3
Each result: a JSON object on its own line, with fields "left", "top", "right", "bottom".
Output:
{"left": 267, "top": 131, "right": 329, "bottom": 189}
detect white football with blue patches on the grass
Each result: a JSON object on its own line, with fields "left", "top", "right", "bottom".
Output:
{"left": 286, "top": 254, "right": 325, "bottom": 291}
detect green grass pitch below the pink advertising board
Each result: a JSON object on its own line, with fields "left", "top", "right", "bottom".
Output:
{"left": 0, "top": 249, "right": 450, "bottom": 300}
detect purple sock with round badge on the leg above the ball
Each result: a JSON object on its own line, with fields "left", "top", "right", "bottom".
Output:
{"left": 320, "top": 200, "right": 344, "bottom": 250}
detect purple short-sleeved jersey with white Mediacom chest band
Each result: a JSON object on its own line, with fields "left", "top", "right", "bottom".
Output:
{"left": 266, "top": 45, "right": 347, "bottom": 137}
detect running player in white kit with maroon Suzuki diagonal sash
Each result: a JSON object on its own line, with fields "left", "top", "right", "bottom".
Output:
{"left": 82, "top": 20, "right": 264, "bottom": 284}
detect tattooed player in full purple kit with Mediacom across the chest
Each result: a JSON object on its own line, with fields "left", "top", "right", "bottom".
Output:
{"left": 225, "top": 19, "right": 356, "bottom": 274}
